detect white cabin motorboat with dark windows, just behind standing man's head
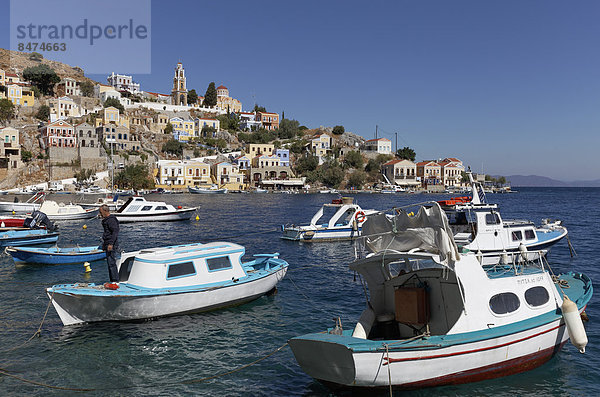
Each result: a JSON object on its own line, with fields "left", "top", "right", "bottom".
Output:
{"left": 114, "top": 196, "right": 196, "bottom": 223}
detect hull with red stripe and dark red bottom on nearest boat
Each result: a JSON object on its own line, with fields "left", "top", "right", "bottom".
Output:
{"left": 290, "top": 320, "right": 569, "bottom": 389}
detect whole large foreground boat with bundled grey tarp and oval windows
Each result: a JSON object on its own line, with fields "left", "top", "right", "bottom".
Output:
{"left": 289, "top": 205, "right": 593, "bottom": 392}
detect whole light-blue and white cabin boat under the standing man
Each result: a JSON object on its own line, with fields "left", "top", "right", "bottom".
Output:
{"left": 46, "top": 242, "right": 288, "bottom": 325}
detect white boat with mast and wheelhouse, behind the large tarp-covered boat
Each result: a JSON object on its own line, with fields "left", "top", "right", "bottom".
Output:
{"left": 438, "top": 172, "right": 568, "bottom": 253}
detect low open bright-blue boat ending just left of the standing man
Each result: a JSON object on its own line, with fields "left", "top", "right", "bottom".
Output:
{"left": 4, "top": 246, "right": 106, "bottom": 265}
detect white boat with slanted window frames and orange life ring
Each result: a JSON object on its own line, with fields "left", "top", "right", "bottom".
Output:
{"left": 281, "top": 197, "right": 377, "bottom": 241}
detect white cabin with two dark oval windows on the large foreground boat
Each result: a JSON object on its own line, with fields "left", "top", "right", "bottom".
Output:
{"left": 350, "top": 252, "right": 560, "bottom": 340}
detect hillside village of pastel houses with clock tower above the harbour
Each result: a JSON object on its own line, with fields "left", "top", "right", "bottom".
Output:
{"left": 0, "top": 49, "right": 478, "bottom": 191}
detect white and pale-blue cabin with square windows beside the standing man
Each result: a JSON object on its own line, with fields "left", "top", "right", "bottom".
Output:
{"left": 119, "top": 242, "right": 246, "bottom": 288}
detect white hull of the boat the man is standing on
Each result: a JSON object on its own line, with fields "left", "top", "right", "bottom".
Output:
{"left": 47, "top": 266, "right": 287, "bottom": 325}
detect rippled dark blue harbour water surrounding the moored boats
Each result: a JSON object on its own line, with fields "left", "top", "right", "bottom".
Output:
{"left": 0, "top": 188, "right": 600, "bottom": 396}
